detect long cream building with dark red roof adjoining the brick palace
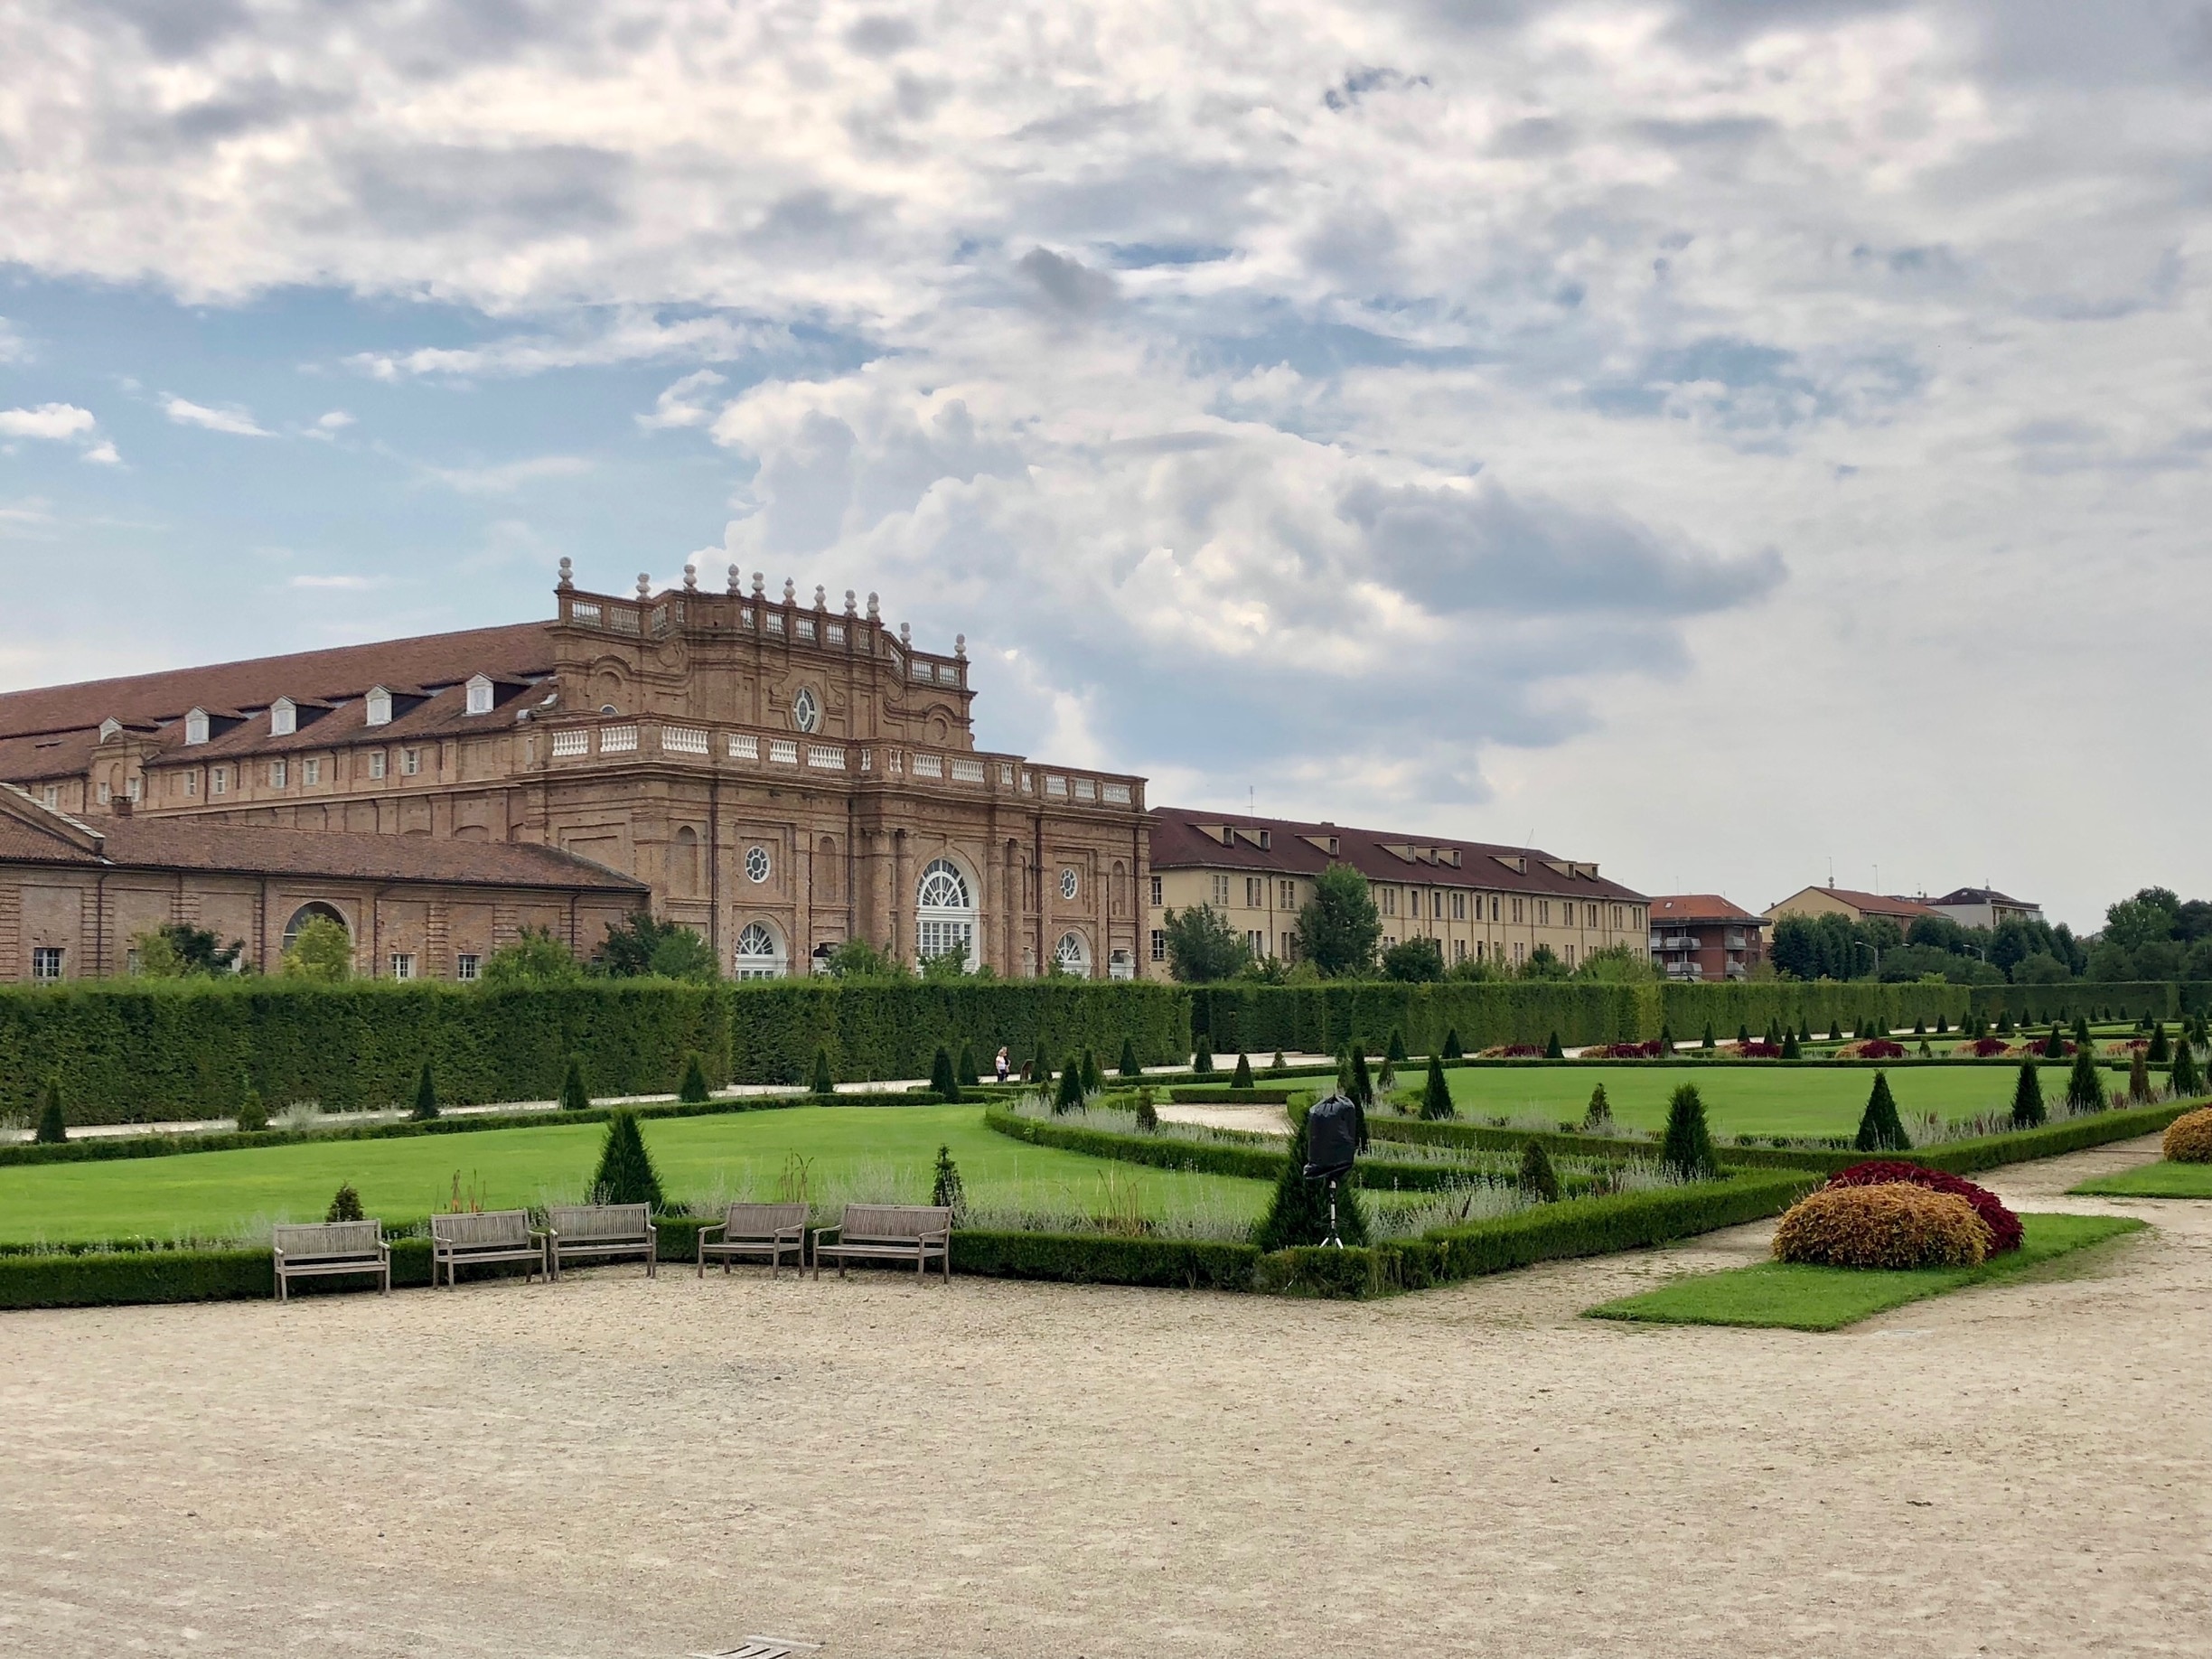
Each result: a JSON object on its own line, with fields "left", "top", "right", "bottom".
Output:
{"left": 1144, "top": 808, "right": 1648, "bottom": 979}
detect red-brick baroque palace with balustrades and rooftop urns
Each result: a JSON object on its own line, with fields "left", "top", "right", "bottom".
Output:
{"left": 0, "top": 559, "right": 1150, "bottom": 978}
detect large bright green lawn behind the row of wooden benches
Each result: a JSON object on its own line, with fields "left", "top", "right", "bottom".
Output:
{"left": 0, "top": 1106, "right": 1268, "bottom": 1243}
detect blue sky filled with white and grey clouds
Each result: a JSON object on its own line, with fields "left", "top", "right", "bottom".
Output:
{"left": 0, "top": 0, "right": 2212, "bottom": 924}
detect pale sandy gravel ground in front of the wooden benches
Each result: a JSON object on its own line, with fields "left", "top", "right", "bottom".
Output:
{"left": 0, "top": 1141, "right": 2212, "bottom": 1659}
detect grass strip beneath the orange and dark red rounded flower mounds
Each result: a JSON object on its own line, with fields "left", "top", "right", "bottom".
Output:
{"left": 1589, "top": 1214, "right": 2143, "bottom": 1332}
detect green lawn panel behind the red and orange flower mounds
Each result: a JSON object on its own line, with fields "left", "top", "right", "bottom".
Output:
{"left": 1409, "top": 1062, "right": 2066, "bottom": 1135}
